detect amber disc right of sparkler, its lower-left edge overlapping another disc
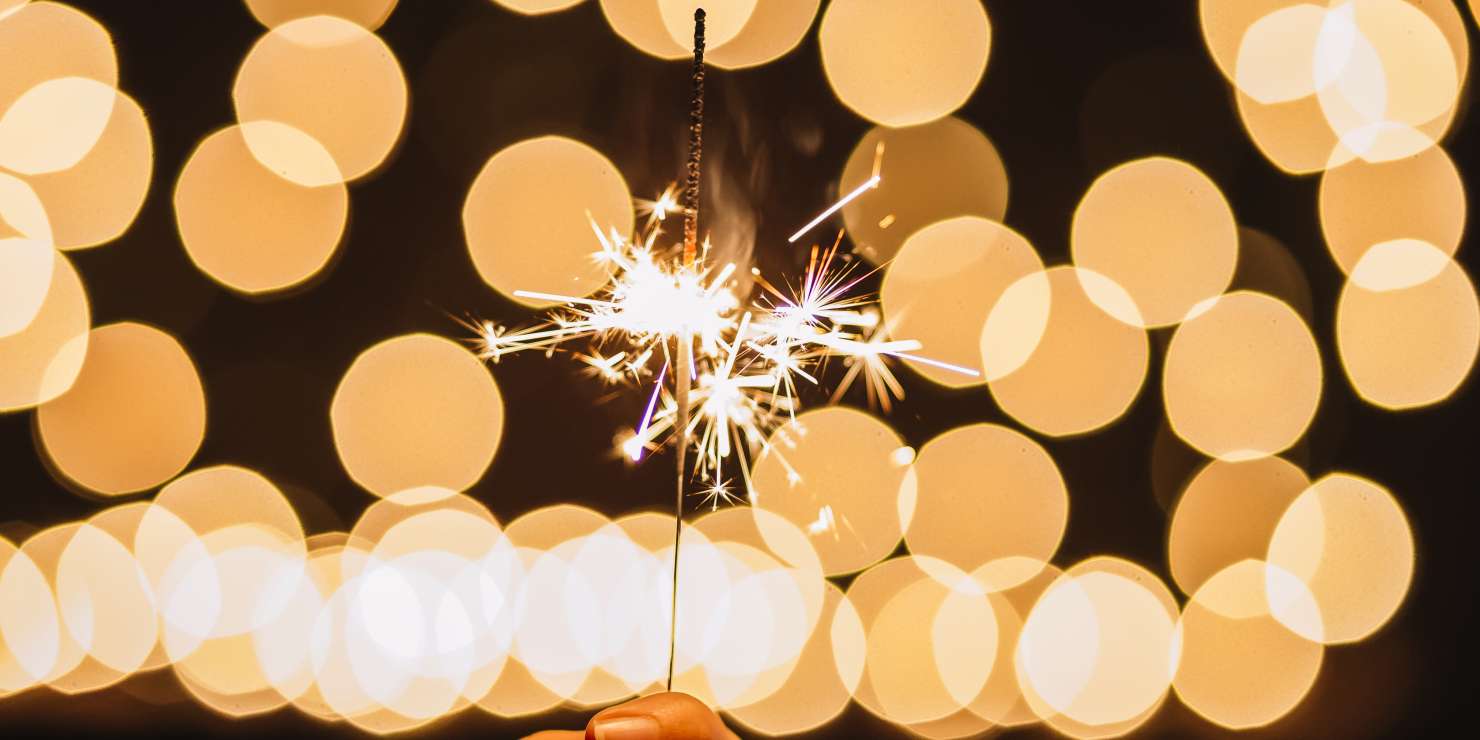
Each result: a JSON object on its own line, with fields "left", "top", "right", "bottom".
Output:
{"left": 1070, "top": 157, "right": 1239, "bottom": 327}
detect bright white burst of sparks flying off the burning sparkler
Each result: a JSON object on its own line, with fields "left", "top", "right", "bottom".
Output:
{"left": 466, "top": 180, "right": 978, "bottom": 509}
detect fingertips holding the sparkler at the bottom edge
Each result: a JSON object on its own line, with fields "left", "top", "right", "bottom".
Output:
{"left": 528, "top": 693, "right": 739, "bottom": 740}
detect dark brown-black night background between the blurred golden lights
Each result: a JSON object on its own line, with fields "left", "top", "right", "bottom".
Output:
{"left": 0, "top": 0, "right": 1480, "bottom": 737}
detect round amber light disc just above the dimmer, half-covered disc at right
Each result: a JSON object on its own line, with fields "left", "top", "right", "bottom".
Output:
{"left": 1162, "top": 290, "right": 1323, "bottom": 460}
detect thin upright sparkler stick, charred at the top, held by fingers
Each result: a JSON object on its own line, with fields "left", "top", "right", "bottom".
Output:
{"left": 667, "top": 7, "right": 704, "bottom": 691}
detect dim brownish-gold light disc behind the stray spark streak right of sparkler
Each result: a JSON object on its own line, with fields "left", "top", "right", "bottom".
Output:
{"left": 838, "top": 117, "right": 1008, "bottom": 265}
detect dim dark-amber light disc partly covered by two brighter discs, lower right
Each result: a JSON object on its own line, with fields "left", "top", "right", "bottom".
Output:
{"left": 1166, "top": 457, "right": 1310, "bottom": 593}
